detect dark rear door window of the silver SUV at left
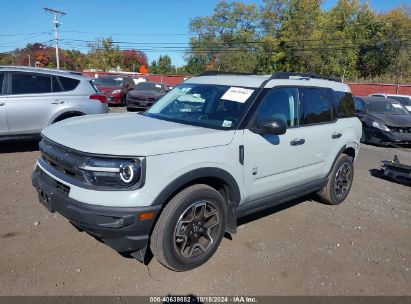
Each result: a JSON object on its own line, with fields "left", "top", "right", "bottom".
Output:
{"left": 11, "top": 72, "right": 51, "bottom": 94}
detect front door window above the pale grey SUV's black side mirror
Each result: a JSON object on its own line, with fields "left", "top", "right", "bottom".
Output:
{"left": 257, "top": 88, "right": 299, "bottom": 127}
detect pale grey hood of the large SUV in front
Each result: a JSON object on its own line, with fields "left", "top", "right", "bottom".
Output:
{"left": 42, "top": 113, "right": 235, "bottom": 156}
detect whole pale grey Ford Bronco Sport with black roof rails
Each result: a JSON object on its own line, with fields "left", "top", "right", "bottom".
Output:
{"left": 32, "top": 72, "right": 361, "bottom": 271}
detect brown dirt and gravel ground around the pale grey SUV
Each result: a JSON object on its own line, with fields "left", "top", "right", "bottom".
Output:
{"left": 0, "top": 113, "right": 411, "bottom": 295}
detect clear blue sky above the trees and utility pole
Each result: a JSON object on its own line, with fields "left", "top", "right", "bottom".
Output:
{"left": 0, "top": 0, "right": 409, "bottom": 66}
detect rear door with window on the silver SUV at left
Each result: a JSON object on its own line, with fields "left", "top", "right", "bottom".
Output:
{"left": 7, "top": 72, "right": 65, "bottom": 135}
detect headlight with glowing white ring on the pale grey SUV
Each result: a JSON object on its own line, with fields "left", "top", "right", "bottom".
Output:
{"left": 80, "top": 158, "right": 141, "bottom": 188}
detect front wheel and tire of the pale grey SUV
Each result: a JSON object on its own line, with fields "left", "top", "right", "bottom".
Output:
{"left": 150, "top": 184, "right": 227, "bottom": 271}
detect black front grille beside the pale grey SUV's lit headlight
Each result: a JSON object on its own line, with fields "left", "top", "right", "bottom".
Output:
{"left": 39, "top": 139, "right": 85, "bottom": 182}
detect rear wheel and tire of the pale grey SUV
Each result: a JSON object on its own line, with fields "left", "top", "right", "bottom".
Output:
{"left": 318, "top": 154, "right": 354, "bottom": 205}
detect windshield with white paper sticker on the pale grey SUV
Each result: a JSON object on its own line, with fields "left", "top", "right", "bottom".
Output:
{"left": 144, "top": 84, "right": 257, "bottom": 130}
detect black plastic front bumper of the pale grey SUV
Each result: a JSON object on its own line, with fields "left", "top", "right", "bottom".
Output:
{"left": 32, "top": 166, "right": 161, "bottom": 260}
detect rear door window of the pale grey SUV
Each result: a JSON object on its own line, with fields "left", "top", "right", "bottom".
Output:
{"left": 300, "top": 88, "right": 333, "bottom": 125}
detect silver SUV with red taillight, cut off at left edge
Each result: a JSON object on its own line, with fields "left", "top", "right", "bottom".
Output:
{"left": 0, "top": 66, "right": 107, "bottom": 140}
